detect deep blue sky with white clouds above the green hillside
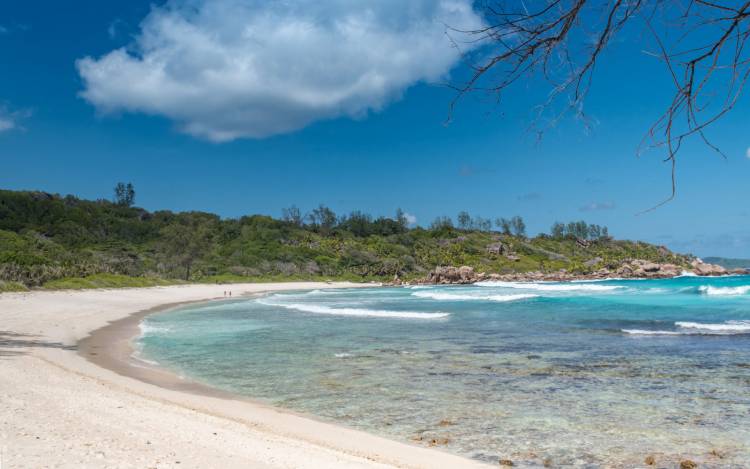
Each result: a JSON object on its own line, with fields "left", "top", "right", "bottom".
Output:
{"left": 0, "top": 0, "right": 750, "bottom": 257}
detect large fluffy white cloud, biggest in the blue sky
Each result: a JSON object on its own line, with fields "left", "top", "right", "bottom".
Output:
{"left": 77, "top": 0, "right": 482, "bottom": 141}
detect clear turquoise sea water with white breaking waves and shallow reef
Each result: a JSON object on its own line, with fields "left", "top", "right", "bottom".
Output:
{"left": 139, "top": 276, "right": 750, "bottom": 468}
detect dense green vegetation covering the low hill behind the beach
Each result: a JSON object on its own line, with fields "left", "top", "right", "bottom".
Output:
{"left": 0, "top": 185, "right": 700, "bottom": 290}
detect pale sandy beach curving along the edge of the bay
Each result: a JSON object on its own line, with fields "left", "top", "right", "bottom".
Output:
{"left": 0, "top": 282, "right": 487, "bottom": 469}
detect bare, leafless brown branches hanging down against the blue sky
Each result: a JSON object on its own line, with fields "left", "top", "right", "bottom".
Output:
{"left": 451, "top": 0, "right": 750, "bottom": 208}
